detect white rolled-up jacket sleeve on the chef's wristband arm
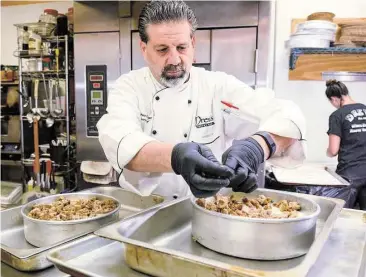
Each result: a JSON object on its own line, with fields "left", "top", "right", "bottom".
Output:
{"left": 217, "top": 73, "right": 306, "bottom": 166}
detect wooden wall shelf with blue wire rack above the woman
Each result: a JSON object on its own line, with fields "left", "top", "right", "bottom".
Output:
{"left": 288, "top": 16, "right": 366, "bottom": 81}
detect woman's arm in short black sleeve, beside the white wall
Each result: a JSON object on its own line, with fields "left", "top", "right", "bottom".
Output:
{"left": 327, "top": 113, "right": 342, "bottom": 158}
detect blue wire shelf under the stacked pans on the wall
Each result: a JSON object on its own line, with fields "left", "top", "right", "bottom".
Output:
{"left": 289, "top": 47, "right": 366, "bottom": 70}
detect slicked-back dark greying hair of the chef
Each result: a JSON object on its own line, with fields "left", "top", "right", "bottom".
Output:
{"left": 138, "top": 0, "right": 197, "bottom": 43}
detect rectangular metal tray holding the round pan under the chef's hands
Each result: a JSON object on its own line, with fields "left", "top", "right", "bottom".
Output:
{"left": 87, "top": 189, "right": 344, "bottom": 277}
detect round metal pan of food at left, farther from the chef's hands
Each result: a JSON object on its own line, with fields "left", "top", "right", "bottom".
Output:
{"left": 21, "top": 193, "right": 121, "bottom": 247}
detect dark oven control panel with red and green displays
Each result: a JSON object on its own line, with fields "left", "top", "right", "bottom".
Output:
{"left": 85, "top": 65, "right": 107, "bottom": 137}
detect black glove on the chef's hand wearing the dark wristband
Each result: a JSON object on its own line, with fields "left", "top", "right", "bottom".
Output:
{"left": 222, "top": 138, "right": 264, "bottom": 193}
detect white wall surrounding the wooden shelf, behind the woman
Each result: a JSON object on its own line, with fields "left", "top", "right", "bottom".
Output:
{"left": 274, "top": 0, "right": 366, "bottom": 163}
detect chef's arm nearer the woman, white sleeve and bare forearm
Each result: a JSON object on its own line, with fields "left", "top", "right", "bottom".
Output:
{"left": 216, "top": 72, "right": 306, "bottom": 162}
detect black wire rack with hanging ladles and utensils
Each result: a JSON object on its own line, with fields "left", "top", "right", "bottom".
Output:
{"left": 15, "top": 23, "right": 75, "bottom": 192}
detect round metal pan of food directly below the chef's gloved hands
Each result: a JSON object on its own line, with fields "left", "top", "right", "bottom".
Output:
{"left": 191, "top": 189, "right": 320, "bottom": 260}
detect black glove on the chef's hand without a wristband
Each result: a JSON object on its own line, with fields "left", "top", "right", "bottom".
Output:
{"left": 171, "top": 142, "right": 232, "bottom": 197}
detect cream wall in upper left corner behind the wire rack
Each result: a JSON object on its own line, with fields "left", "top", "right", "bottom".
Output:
{"left": 1, "top": 1, "right": 73, "bottom": 65}
